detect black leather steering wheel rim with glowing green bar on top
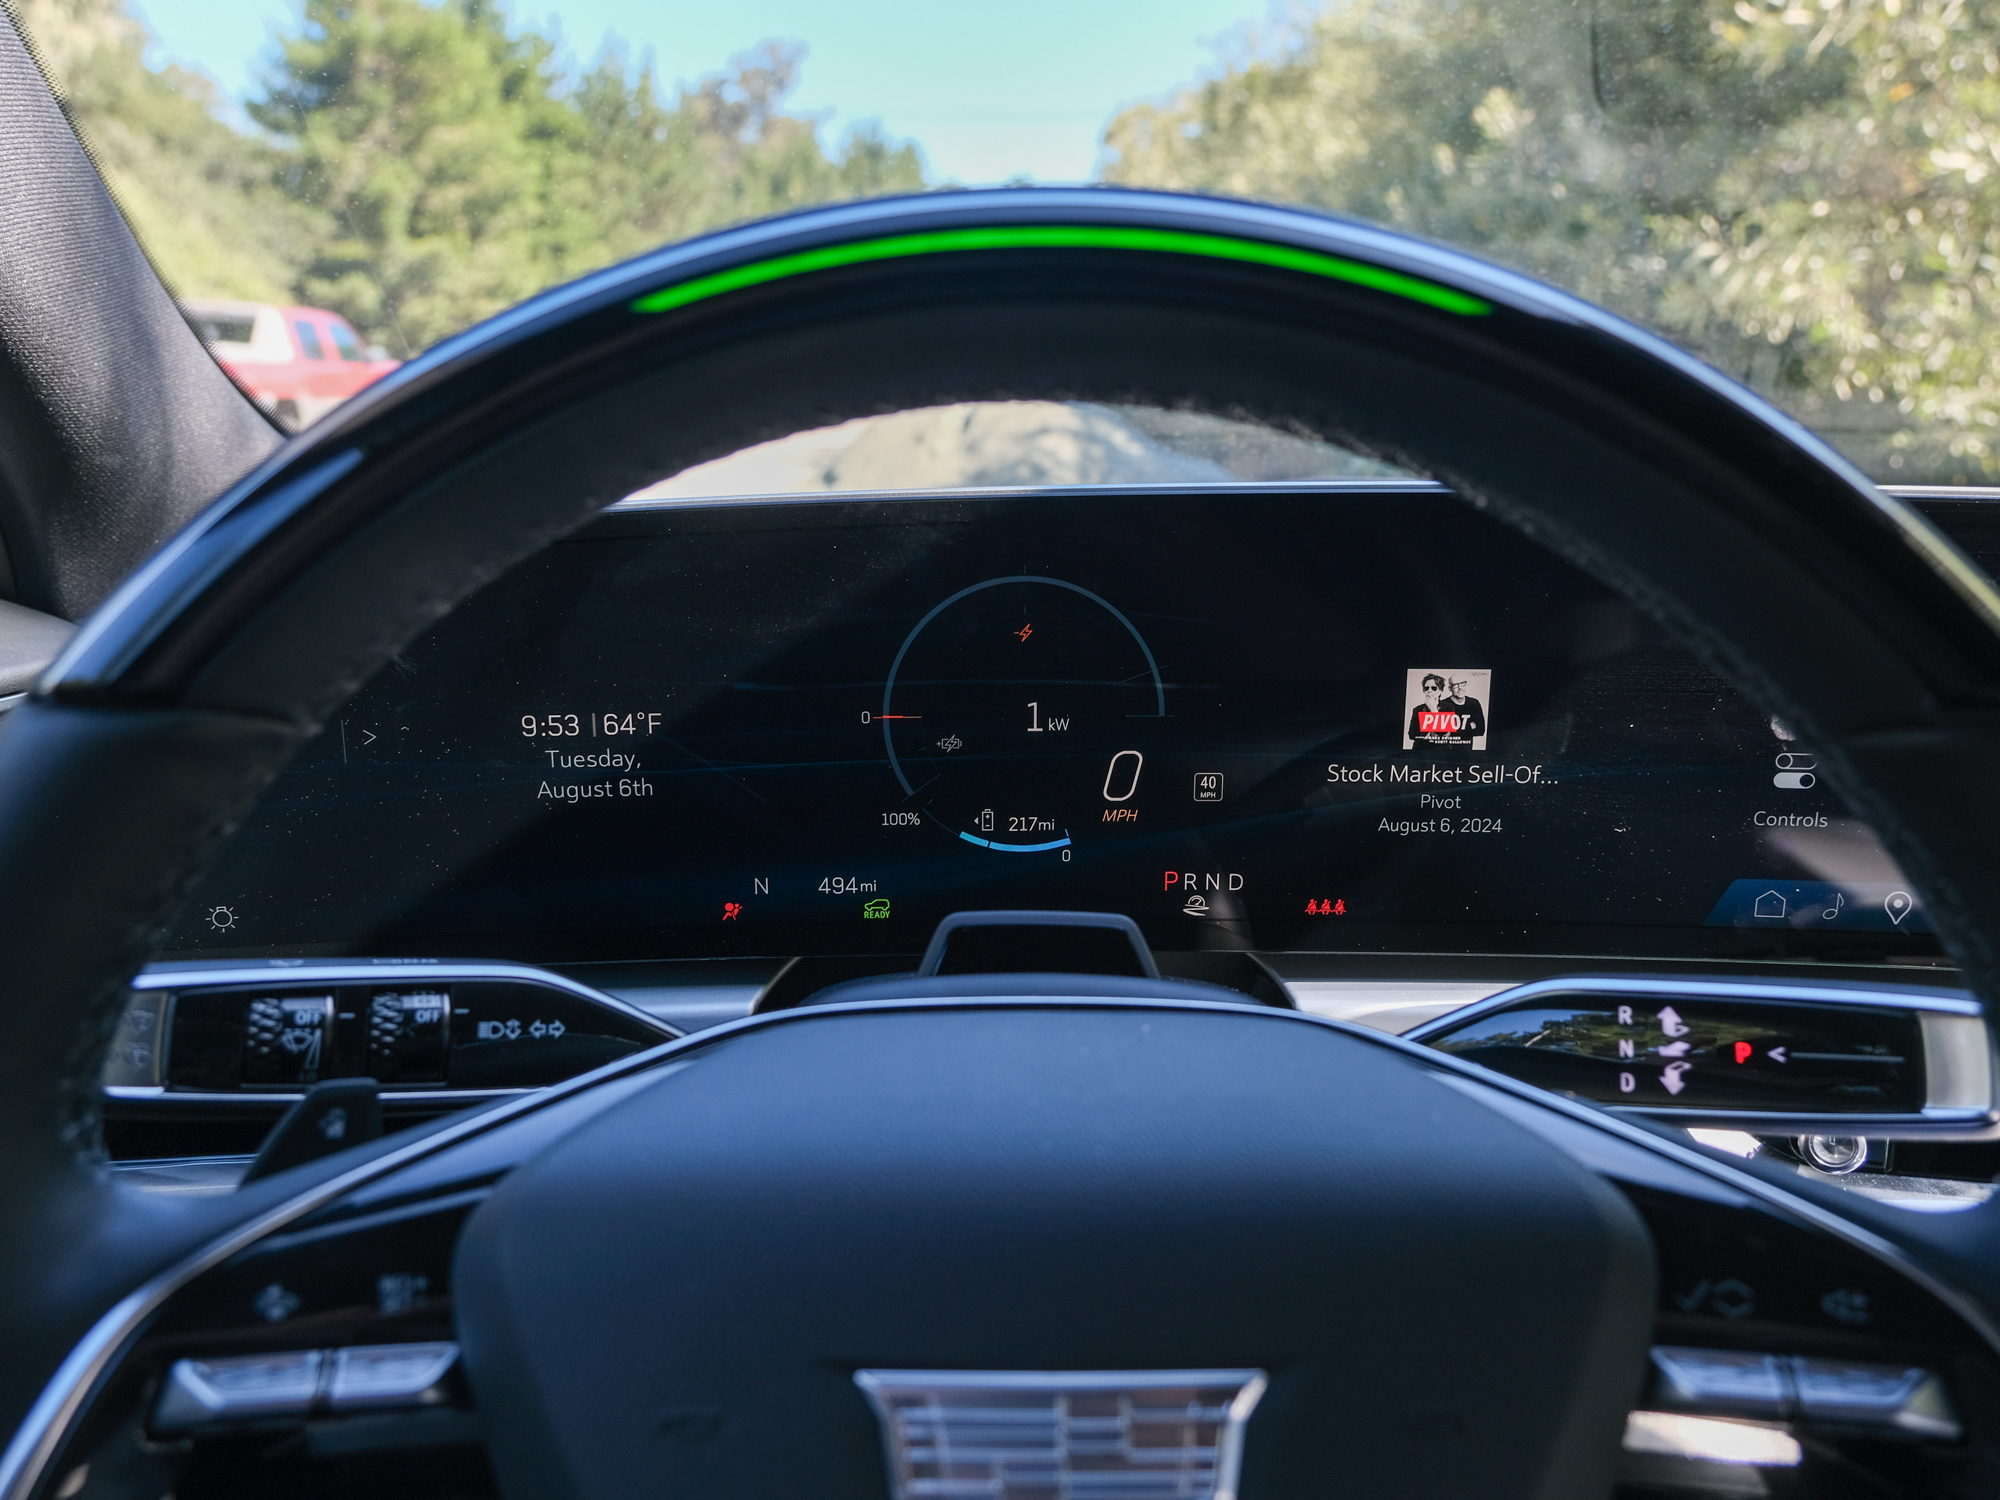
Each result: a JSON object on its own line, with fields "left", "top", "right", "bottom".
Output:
{"left": 0, "top": 190, "right": 2000, "bottom": 1448}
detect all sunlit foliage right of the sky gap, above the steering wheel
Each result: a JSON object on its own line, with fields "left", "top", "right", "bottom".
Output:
{"left": 1104, "top": 0, "right": 2000, "bottom": 478}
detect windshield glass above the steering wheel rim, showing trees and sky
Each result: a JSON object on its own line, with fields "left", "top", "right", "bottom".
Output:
{"left": 16, "top": 0, "right": 2000, "bottom": 484}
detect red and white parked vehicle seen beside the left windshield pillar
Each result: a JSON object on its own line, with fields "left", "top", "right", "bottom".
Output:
{"left": 180, "top": 298, "right": 402, "bottom": 428}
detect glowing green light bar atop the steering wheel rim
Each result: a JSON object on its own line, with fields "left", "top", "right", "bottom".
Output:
{"left": 632, "top": 224, "right": 1494, "bottom": 318}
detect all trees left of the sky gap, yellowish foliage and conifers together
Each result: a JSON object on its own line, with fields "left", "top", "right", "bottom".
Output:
{"left": 18, "top": 0, "right": 924, "bottom": 354}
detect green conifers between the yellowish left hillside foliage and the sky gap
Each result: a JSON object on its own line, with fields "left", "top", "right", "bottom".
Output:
{"left": 250, "top": 0, "right": 924, "bottom": 352}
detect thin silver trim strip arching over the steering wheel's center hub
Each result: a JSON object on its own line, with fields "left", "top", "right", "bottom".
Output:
{"left": 15, "top": 996, "right": 2000, "bottom": 1500}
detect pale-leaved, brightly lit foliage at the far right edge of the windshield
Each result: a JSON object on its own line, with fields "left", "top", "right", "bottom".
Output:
{"left": 1658, "top": 0, "right": 2000, "bottom": 474}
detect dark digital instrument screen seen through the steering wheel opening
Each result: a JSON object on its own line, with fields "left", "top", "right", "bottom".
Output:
{"left": 170, "top": 486, "right": 1934, "bottom": 962}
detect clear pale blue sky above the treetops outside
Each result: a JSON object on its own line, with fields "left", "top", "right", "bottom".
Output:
{"left": 134, "top": 0, "right": 1286, "bottom": 184}
